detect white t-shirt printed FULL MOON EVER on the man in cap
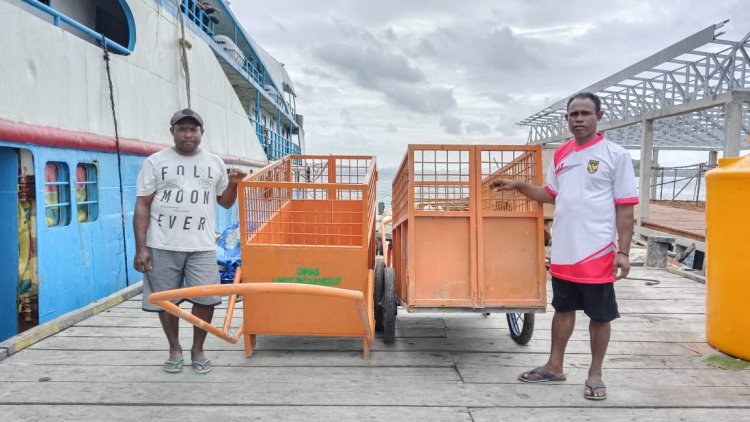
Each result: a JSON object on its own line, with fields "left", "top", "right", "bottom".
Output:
{"left": 136, "top": 148, "right": 229, "bottom": 252}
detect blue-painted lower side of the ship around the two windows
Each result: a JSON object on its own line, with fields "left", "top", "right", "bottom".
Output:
{"left": 0, "top": 139, "right": 237, "bottom": 341}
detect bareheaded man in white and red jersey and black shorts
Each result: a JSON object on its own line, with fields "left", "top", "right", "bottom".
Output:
{"left": 493, "top": 92, "right": 638, "bottom": 400}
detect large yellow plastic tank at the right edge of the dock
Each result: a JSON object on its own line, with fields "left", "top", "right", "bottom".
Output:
{"left": 706, "top": 155, "right": 750, "bottom": 360}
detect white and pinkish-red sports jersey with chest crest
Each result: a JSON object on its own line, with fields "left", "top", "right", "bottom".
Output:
{"left": 544, "top": 133, "right": 638, "bottom": 284}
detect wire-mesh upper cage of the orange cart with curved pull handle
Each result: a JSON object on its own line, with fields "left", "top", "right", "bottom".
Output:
{"left": 240, "top": 155, "right": 376, "bottom": 246}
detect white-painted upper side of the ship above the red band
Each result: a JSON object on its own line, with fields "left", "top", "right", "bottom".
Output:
{"left": 0, "top": 0, "right": 267, "bottom": 162}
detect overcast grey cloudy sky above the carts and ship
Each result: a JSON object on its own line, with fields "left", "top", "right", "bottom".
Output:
{"left": 231, "top": 0, "right": 750, "bottom": 167}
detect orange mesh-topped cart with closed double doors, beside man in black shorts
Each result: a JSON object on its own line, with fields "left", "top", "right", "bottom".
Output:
{"left": 375, "top": 145, "right": 547, "bottom": 344}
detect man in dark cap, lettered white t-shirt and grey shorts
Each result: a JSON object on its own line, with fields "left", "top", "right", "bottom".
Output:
{"left": 133, "top": 108, "right": 245, "bottom": 374}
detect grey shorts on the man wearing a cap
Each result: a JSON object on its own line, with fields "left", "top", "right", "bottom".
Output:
{"left": 142, "top": 248, "right": 221, "bottom": 312}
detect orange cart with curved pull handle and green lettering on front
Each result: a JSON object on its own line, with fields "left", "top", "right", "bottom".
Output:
{"left": 151, "top": 155, "right": 377, "bottom": 358}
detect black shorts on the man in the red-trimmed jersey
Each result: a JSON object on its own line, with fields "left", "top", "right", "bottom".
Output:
{"left": 552, "top": 276, "right": 620, "bottom": 322}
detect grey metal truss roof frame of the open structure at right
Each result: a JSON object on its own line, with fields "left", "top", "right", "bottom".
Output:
{"left": 518, "top": 20, "right": 750, "bottom": 150}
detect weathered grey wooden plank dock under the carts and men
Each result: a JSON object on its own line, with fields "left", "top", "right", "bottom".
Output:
{"left": 0, "top": 267, "right": 750, "bottom": 422}
